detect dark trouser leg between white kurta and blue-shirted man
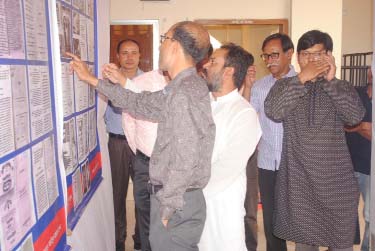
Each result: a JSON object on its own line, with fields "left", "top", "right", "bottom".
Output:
{"left": 245, "top": 151, "right": 258, "bottom": 251}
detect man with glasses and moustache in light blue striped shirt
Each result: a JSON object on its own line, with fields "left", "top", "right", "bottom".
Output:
{"left": 243, "top": 33, "right": 296, "bottom": 251}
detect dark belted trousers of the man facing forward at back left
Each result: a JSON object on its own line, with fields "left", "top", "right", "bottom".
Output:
{"left": 108, "top": 136, "right": 140, "bottom": 250}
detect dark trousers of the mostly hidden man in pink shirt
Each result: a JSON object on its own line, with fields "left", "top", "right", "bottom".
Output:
{"left": 133, "top": 150, "right": 151, "bottom": 251}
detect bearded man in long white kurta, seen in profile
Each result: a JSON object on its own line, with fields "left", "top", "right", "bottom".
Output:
{"left": 199, "top": 44, "right": 261, "bottom": 251}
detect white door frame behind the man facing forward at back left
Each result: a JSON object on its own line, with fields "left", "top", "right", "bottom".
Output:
{"left": 110, "top": 19, "right": 160, "bottom": 70}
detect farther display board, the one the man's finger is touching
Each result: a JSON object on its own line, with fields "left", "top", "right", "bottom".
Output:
{"left": 56, "top": 0, "right": 102, "bottom": 230}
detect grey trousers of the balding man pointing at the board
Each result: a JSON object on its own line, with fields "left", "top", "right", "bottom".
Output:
{"left": 150, "top": 189, "right": 206, "bottom": 251}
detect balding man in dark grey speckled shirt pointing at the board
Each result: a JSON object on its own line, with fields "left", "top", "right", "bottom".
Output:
{"left": 70, "top": 21, "right": 215, "bottom": 251}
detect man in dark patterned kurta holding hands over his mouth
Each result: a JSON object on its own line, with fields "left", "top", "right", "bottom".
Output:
{"left": 264, "top": 30, "right": 365, "bottom": 251}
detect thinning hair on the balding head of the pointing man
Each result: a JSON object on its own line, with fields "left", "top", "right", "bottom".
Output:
{"left": 172, "top": 21, "right": 210, "bottom": 64}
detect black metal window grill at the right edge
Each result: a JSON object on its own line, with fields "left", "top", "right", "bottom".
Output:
{"left": 341, "top": 52, "right": 372, "bottom": 86}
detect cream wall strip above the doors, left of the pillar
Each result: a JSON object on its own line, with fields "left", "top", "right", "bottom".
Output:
{"left": 111, "top": 0, "right": 291, "bottom": 33}
